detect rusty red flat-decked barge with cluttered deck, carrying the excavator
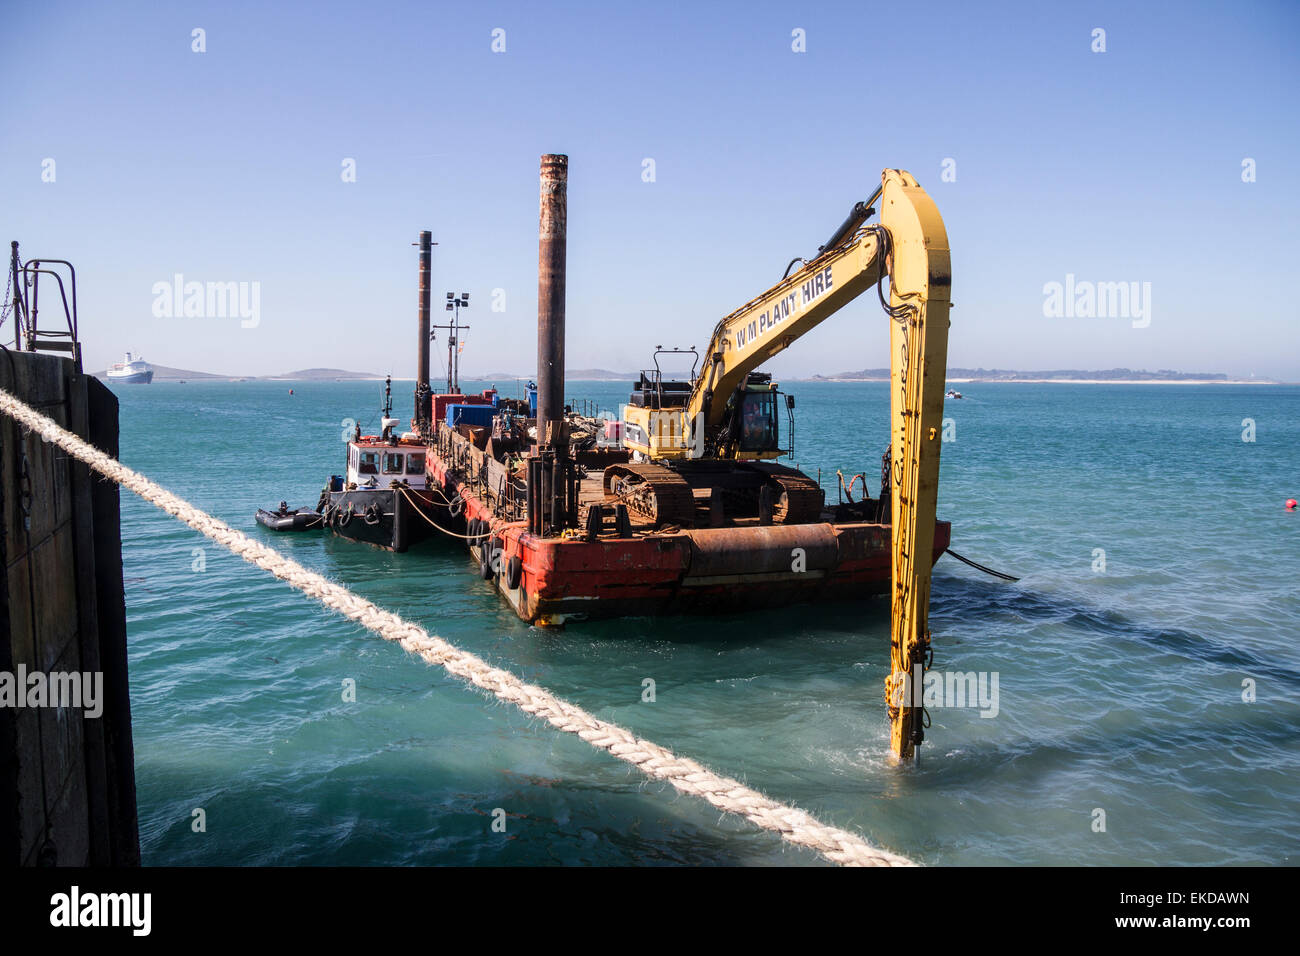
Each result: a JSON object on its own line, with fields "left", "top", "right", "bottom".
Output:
{"left": 425, "top": 413, "right": 952, "bottom": 626}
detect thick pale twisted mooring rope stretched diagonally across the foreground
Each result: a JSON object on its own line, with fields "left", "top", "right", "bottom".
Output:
{"left": 0, "top": 389, "right": 914, "bottom": 866}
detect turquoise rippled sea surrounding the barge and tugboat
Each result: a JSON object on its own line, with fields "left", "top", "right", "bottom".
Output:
{"left": 116, "top": 382, "right": 1300, "bottom": 865}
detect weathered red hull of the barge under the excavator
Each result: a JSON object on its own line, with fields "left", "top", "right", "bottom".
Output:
{"left": 426, "top": 425, "right": 952, "bottom": 626}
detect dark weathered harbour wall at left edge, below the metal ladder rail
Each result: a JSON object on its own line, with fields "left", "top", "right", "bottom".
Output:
{"left": 0, "top": 349, "right": 140, "bottom": 866}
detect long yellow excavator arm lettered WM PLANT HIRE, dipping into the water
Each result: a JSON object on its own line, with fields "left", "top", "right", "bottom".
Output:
{"left": 684, "top": 169, "right": 952, "bottom": 760}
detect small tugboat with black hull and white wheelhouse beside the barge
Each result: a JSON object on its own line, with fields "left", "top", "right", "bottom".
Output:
{"left": 316, "top": 376, "right": 436, "bottom": 551}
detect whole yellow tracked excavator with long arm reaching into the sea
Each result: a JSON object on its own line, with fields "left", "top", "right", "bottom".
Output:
{"left": 603, "top": 169, "right": 952, "bottom": 758}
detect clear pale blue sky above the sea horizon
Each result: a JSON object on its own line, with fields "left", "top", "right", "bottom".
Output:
{"left": 0, "top": 0, "right": 1300, "bottom": 381}
